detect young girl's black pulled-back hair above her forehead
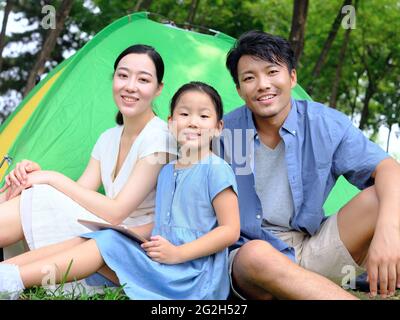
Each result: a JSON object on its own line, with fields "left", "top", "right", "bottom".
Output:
{"left": 170, "top": 81, "right": 224, "bottom": 121}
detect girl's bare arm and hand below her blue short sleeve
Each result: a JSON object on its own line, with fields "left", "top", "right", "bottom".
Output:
{"left": 142, "top": 188, "right": 240, "bottom": 264}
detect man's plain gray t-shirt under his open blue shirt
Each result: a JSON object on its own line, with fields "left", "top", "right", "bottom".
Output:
{"left": 254, "top": 140, "right": 294, "bottom": 232}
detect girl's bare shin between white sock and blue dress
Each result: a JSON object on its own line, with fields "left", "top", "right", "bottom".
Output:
{"left": 19, "top": 239, "right": 104, "bottom": 288}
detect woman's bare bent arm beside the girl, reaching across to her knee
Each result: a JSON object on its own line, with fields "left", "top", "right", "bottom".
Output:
{"left": 23, "top": 153, "right": 166, "bottom": 224}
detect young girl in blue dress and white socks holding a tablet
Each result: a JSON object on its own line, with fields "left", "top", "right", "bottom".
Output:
{"left": 0, "top": 82, "right": 240, "bottom": 299}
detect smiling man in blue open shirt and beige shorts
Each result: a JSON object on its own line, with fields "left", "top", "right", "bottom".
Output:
{"left": 220, "top": 31, "right": 400, "bottom": 299}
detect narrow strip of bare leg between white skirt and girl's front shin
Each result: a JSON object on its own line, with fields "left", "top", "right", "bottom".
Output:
{"left": 4, "top": 237, "right": 87, "bottom": 267}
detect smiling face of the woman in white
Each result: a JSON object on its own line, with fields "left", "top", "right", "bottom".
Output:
{"left": 113, "top": 53, "right": 163, "bottom": 118}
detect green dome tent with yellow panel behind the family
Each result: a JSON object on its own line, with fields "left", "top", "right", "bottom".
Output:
{"left": 0, "top": 13, "right": 357, "bottom": 214}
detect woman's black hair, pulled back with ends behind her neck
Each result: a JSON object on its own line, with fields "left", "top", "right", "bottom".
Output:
{"left": 114, "top": 44, "right": 164, "bottom": 125}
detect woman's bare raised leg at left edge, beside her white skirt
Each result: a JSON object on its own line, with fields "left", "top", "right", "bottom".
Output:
{"left": 0, "top": 196, "right": 24, "bottom": 248}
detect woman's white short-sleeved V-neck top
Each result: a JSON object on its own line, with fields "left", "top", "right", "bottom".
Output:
{"left": 92, "top": 117, "right": 177, "bottom": 226}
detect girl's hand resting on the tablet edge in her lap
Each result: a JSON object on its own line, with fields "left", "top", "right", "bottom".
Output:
{"left": 141, "top": 236, "right": 183, "bottom": 264}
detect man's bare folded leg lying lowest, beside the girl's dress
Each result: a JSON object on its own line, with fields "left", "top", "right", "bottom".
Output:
{"left": 232, "top": 240, "right": 356, "bottom": 300}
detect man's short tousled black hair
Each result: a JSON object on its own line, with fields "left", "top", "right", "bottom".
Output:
{"left": 226, "top": 30, "right": 296, "bottom": 86}
